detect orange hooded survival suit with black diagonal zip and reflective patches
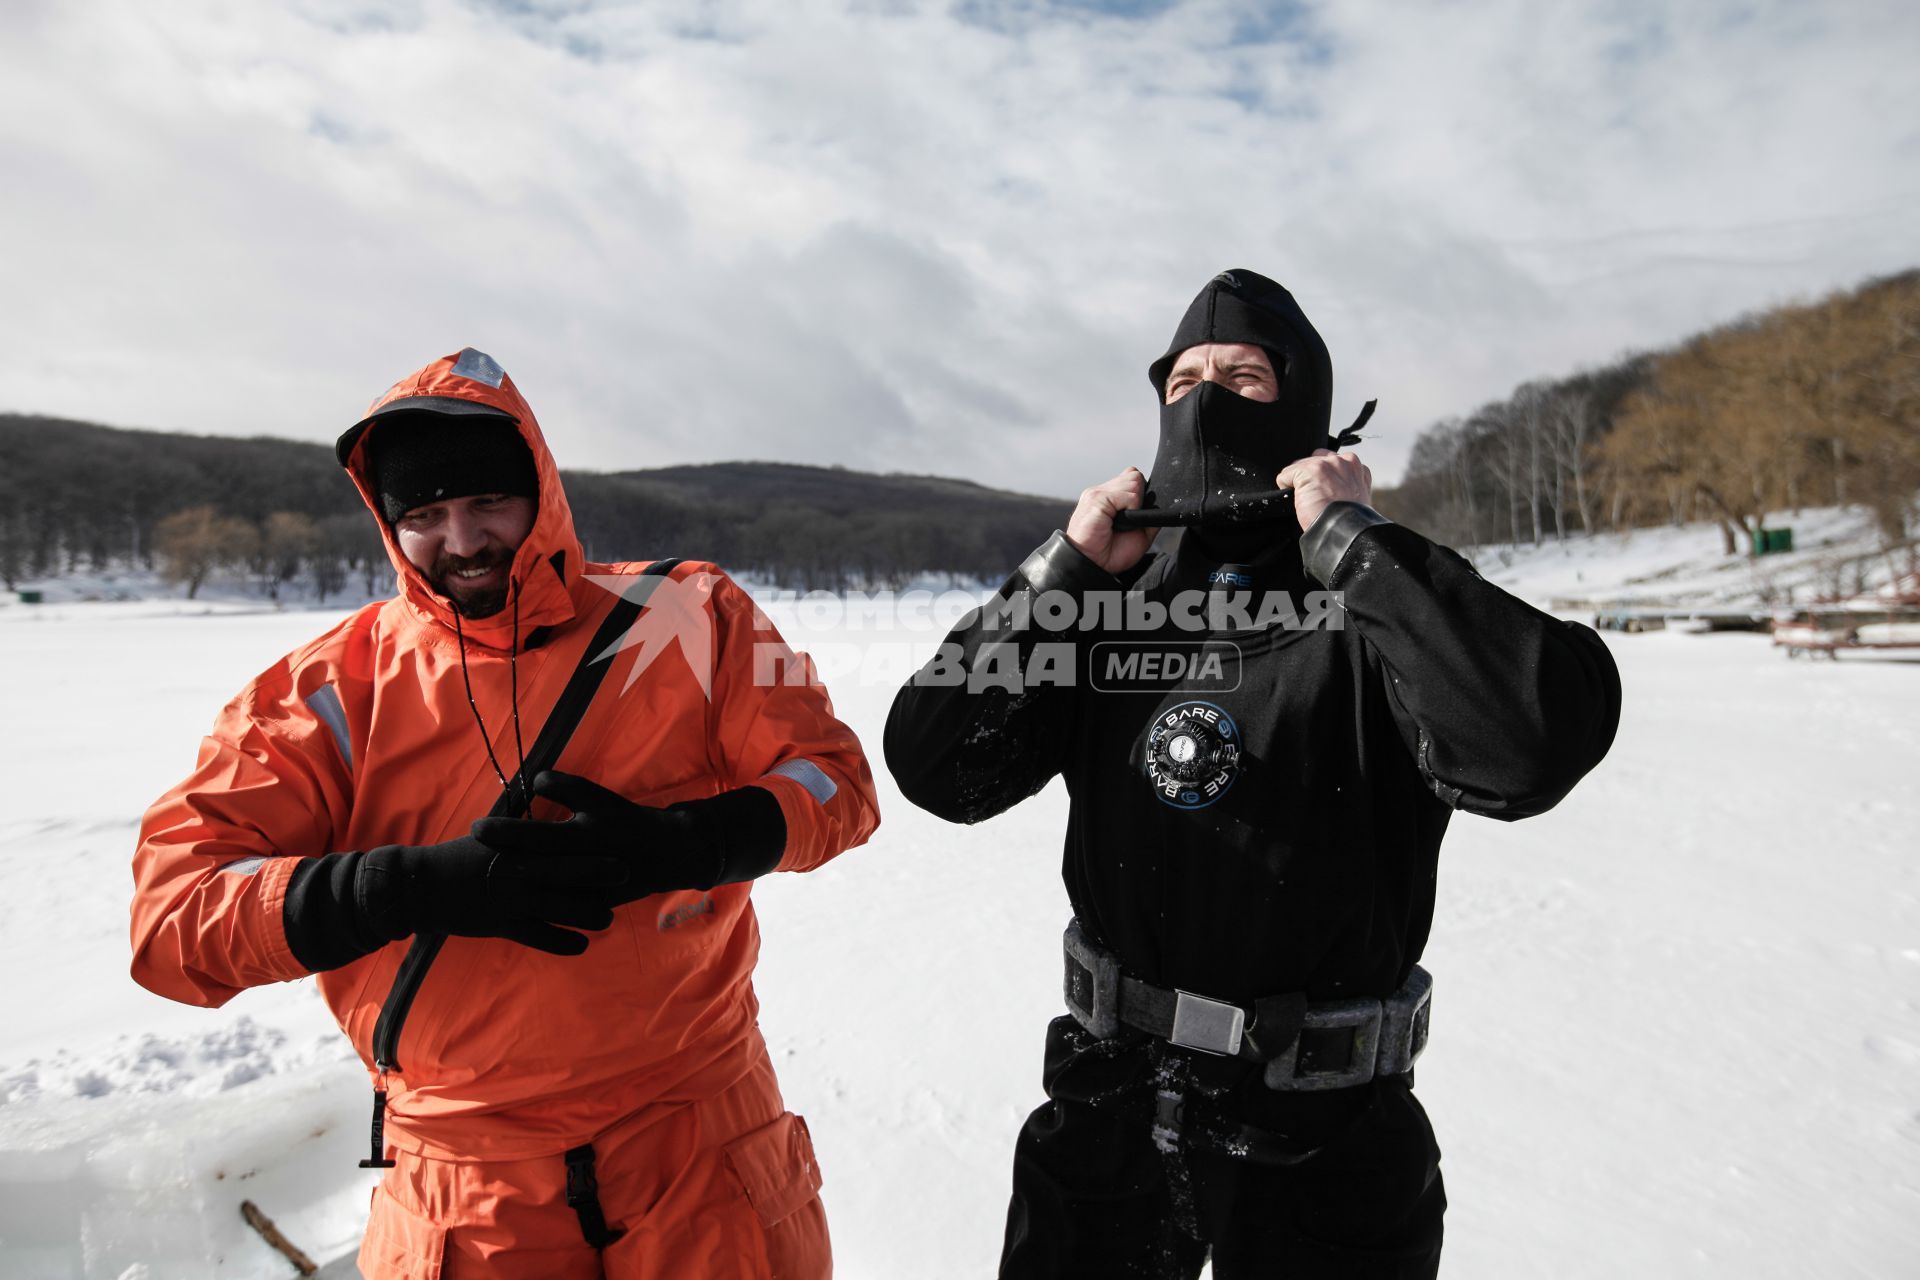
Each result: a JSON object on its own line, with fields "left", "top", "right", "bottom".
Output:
{"left": 132, "top": 351, "right": 879, "bottom": 1278}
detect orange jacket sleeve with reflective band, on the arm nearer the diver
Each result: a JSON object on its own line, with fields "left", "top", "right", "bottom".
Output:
{"left": 710, "top": 572, "right": 879, "bottom": 871}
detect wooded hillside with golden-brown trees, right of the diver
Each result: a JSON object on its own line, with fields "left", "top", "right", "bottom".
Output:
{"left": 1379, "top": 271, "right": 1920, "bottom": 555}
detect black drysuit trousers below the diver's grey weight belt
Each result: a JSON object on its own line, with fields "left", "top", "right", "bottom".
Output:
{"left": 1000, "top": 1017, "right": 1446, "bottom": 1280}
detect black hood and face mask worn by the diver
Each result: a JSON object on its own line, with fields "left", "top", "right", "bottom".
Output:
{"left": 1127, "top": 269, "right": 1332, "bottom": 541}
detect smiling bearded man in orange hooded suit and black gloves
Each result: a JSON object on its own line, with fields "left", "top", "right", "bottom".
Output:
{"left": 132, "top": 347, "right": 879, "bottom": 1280}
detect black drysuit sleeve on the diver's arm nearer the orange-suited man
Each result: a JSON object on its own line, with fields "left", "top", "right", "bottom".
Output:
{"left": 885, "top": 530, "right": 1119, "bottom": 823}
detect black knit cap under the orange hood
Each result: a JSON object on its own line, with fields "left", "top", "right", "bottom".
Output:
{"left": 367, "top": 409, "right": 540, "bottom": 524}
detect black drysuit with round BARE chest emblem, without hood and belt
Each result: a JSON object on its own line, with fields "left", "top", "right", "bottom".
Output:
{"left": 885, "top": 503, "right": 1620, "bottom": 1280}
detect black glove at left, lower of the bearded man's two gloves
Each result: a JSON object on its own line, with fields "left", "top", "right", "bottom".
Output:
{"left": 282, "top": 837, "right": 626, "bottom": 973}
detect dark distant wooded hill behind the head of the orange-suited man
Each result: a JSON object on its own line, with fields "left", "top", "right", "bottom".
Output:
{"left": 0, "top": 415, "right": 1071, "bottom": 601}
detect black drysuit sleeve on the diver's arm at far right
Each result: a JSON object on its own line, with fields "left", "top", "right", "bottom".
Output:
{"left": 1300, "top": 503, "right": 1620, "bottom": 819}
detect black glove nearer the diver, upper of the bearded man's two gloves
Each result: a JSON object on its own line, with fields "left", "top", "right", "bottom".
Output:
{"left": 474, "top": 771, "right": 787, "bottom": 904}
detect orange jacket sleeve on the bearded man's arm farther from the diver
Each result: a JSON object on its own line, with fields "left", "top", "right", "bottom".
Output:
{"left": 132, "top": 666, "right": 349, "bottom": 1006}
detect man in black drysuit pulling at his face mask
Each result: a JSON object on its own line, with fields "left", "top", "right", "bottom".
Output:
{"left": 885, "top": 271, "right": 1620, "bottom": 1280}
